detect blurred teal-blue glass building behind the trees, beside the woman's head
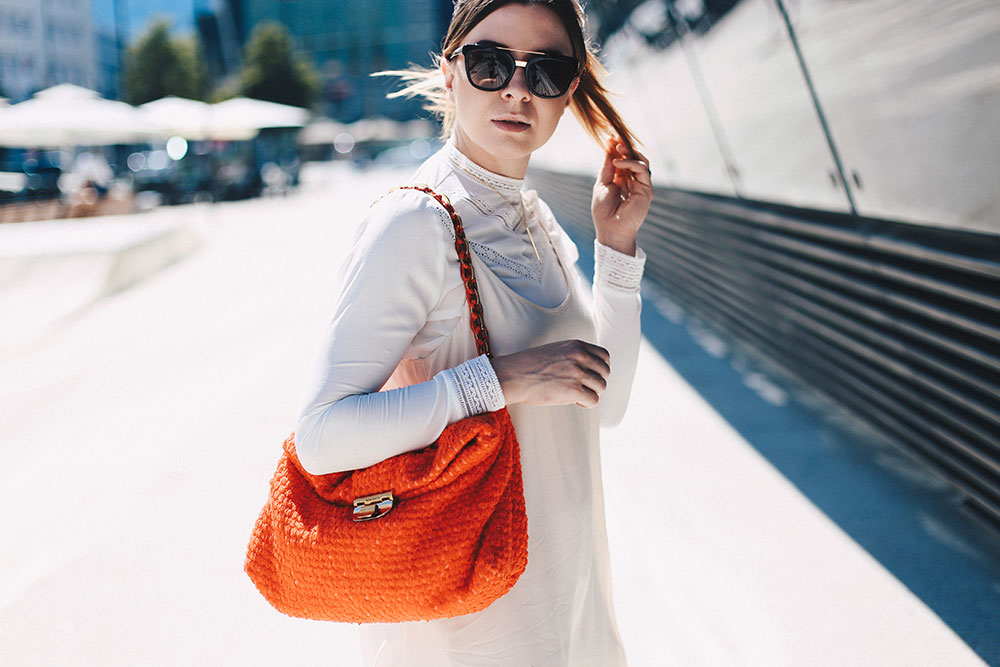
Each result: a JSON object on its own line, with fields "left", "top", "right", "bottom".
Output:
{"left": 224, "top": 0, "right": 453, "bottom": 122}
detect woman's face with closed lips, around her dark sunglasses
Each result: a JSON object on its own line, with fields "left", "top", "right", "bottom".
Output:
{"left": 441, "top": 4, "right": 578, "bottom": 178}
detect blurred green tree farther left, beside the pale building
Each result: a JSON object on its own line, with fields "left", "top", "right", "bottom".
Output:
{"left": 123, "top": 20, "right": 205, "bottom": 104}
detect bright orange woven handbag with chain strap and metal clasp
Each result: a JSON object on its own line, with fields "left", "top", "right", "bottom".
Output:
{"left": 244, "top": 186, "right": 528, "bottom": 623}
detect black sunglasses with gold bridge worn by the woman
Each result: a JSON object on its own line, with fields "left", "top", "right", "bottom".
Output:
{"left": 449, "top": 44, "right": 580, "bottom": 98}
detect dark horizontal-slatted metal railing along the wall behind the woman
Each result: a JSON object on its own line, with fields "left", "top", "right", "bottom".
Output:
{"left": 531, "top": 170, "right": 1000, "bottom": 524}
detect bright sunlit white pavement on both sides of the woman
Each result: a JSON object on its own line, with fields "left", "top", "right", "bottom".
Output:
{"left": 0, "top": 167, "right": 983, "bottom": 667}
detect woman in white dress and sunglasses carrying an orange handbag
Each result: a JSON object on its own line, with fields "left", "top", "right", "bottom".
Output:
{"left": 295, "top": 0, "right": 652, "bottom": 667}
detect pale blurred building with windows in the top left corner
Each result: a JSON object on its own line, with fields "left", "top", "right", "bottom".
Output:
{"left": 0, "top": 0, "right": 98, "bottom": 102}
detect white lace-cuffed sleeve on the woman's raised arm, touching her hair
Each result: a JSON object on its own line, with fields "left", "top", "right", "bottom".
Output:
{"left": 593, "top": 241, "right": 646, "bottom": 427}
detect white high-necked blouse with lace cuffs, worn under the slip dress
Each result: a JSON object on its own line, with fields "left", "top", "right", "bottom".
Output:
{"left": 295, "top": 143, "right": 645, "bottom": 474}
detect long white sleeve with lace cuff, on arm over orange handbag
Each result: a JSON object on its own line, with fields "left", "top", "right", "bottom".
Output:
{"left": 295, "top": 192, "right": 504, "bottom": 474}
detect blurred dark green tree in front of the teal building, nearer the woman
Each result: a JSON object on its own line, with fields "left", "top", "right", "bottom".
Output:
{"left": 240, "top": 23, "right": 319, "bottom": 107}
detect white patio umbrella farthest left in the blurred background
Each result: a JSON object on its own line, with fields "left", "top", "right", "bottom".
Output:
{"left": 0, "top": 83, "right": 150, "bottom": 148}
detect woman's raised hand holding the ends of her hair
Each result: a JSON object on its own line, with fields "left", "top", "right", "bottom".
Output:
{"left": 590, "top": 139, "right": 653, "bottom": 256}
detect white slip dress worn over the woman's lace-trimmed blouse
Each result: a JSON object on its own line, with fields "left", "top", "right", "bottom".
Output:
{"left": 361, "top": 196, "right": 625, "bottom": 667}
